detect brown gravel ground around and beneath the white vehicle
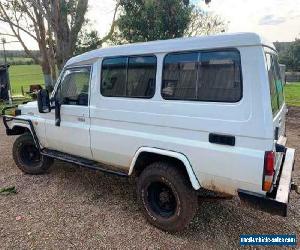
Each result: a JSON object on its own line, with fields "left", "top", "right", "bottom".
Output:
{"left": 0, "top": 108, "right": 300, "bottom": 249}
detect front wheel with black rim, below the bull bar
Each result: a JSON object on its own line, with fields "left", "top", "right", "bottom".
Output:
{"left": 13, "top": 133, "right": 53, "bottom": 174}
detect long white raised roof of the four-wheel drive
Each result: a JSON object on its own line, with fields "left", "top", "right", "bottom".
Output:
{"left": 66, "top": 33, "right": 275, "bottom": 66}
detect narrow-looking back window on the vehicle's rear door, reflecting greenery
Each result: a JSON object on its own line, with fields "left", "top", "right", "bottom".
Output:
{"left": 266, "top": 52, "right": 284, "bottom": 116}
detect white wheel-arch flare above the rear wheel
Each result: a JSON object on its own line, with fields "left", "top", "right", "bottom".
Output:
{"left": 128, "top": 147, "right": 201, "bottom": 190}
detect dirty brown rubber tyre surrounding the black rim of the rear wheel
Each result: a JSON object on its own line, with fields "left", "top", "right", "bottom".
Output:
{"left": 137, "top": 162, "right": 198, "bottom": 232}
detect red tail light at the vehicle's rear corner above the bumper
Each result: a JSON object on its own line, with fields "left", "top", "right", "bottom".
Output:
{"left": 263, "top": 151, "right": 275, "bottom": 192}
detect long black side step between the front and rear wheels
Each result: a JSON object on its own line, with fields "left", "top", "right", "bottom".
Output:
{"left": 41, "top": 149, "right": 128, "bottom": 177}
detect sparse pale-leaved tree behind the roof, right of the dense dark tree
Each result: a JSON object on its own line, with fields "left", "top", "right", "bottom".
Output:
{"left": 184, "top": 7, "right": 227, "bottom": 36}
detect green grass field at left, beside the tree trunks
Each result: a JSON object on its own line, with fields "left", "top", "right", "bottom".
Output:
{"left": 9, "top": 65, "right": 44, "bottom": 95}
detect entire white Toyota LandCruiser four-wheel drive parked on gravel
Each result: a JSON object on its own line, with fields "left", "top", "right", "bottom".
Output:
{"left": 2, "top": 33, "right": 298, "bottom": 231}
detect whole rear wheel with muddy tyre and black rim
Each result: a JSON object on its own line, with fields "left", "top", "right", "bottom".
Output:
{"left": 138, "top": 162, "right": 198, "bottom": 232}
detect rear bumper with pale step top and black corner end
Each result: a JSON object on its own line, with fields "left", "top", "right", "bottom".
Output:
{"left": 238, "top": 148, "right": 295, "bottom": 217}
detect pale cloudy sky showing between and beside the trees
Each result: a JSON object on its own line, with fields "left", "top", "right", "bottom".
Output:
{"left": 0, "top": 0, "right": 300, "bottom": 49}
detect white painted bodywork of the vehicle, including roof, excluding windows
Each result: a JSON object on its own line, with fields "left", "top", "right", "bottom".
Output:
{"left": 14, "top": 33, "right": 285, "bottom": 194}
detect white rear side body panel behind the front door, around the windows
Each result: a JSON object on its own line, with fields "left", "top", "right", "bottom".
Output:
{"left": 90, "top": 46, "right": 273, "bottom": 194}
